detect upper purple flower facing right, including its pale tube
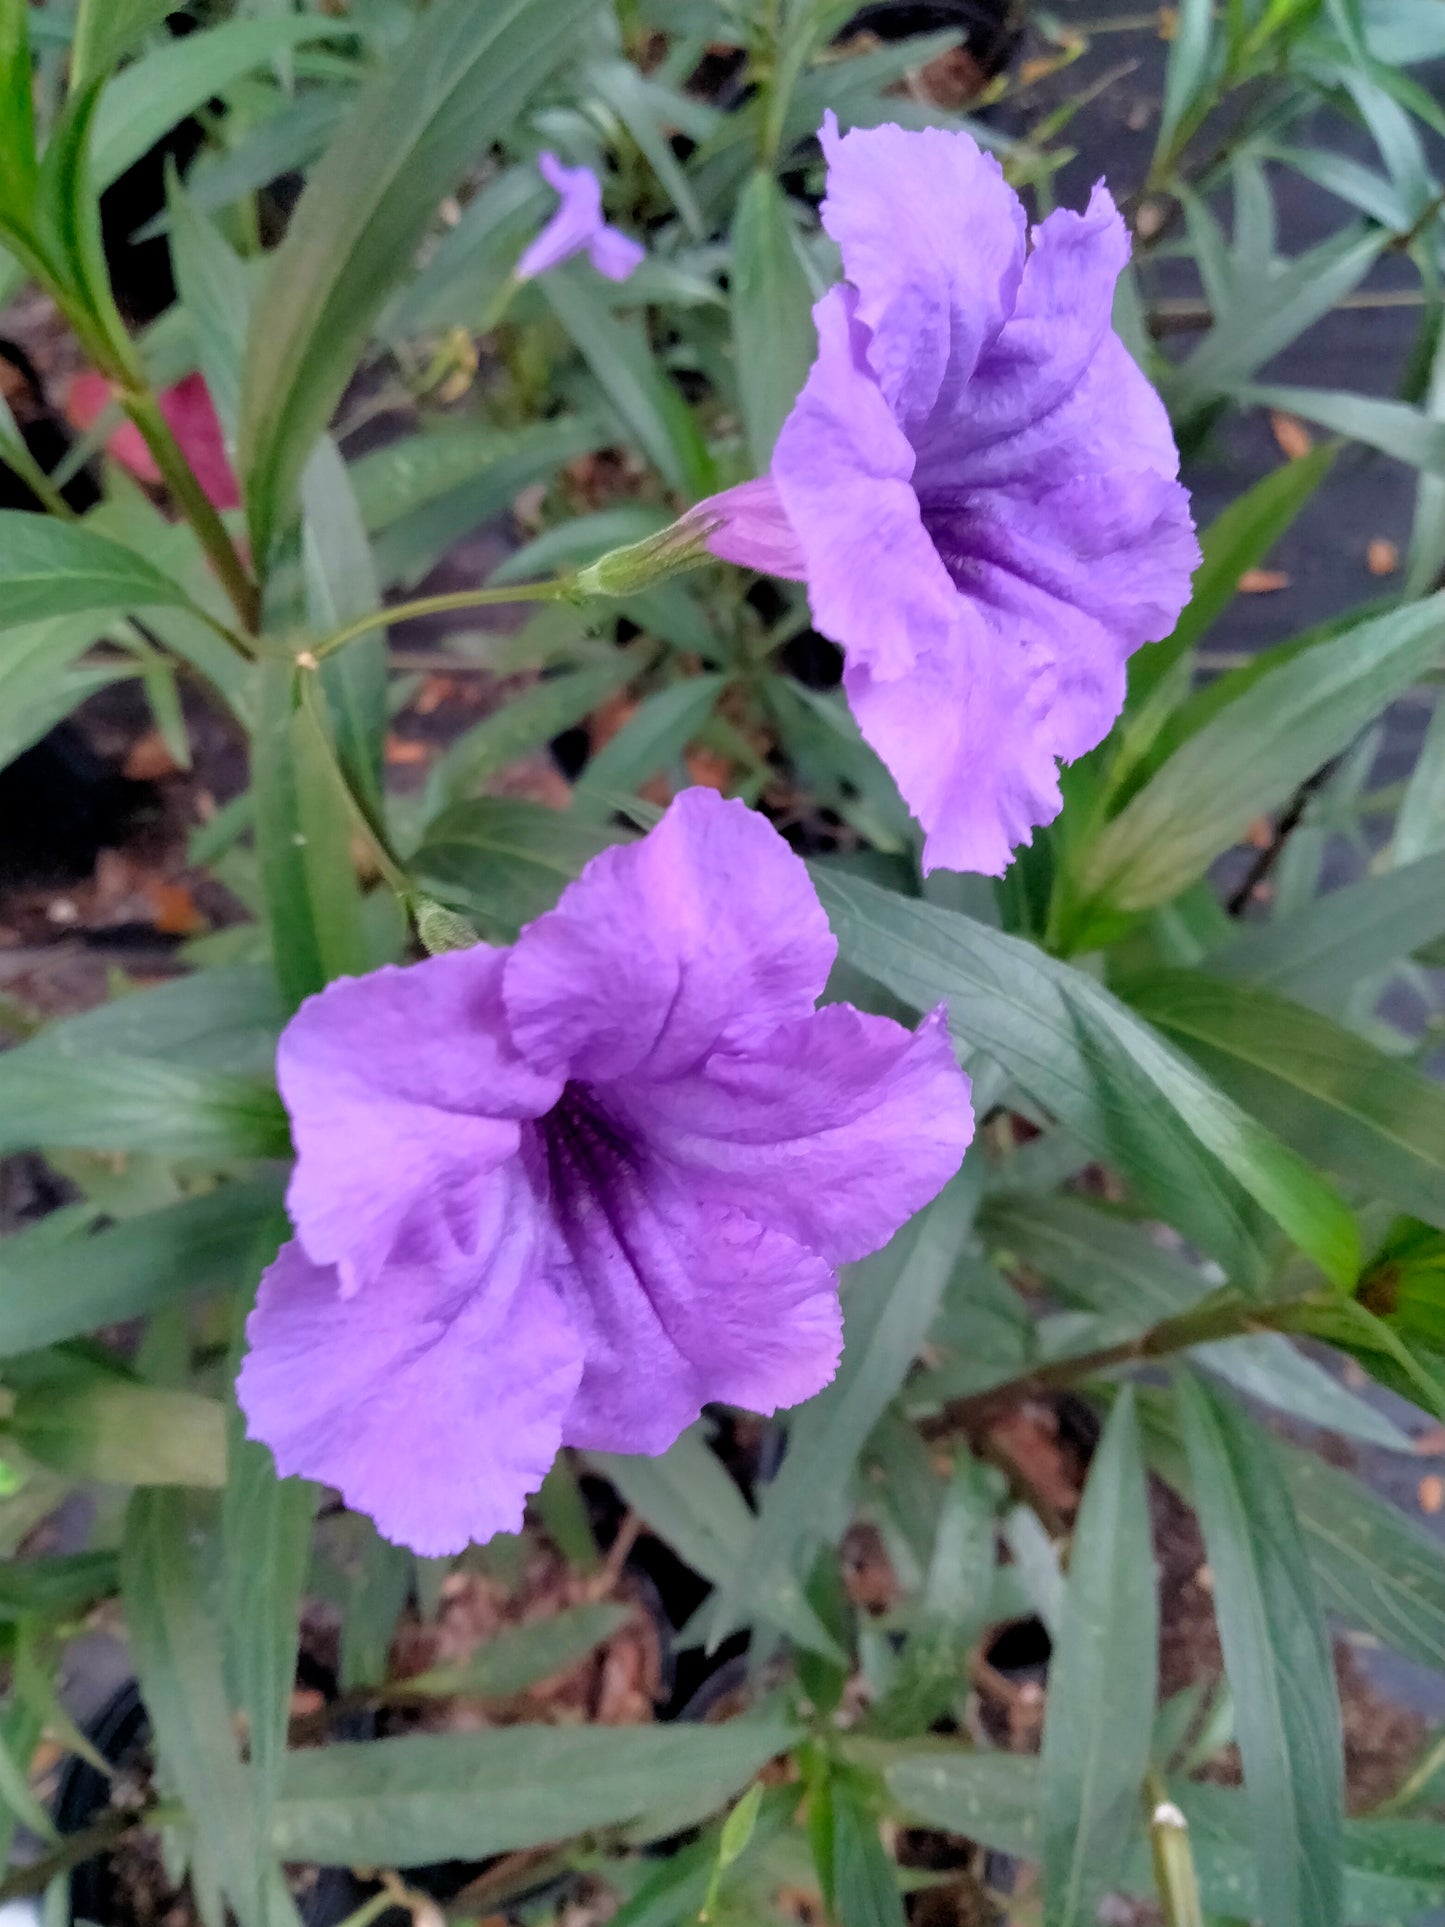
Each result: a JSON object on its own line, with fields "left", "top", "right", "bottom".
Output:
{"left": 701, "top": 116, "right": 1198, "bottom": 875}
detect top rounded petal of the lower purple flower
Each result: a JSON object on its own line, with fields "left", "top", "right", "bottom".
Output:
{"left": 503, "top": 788, "right": 836, "bottom": 1081}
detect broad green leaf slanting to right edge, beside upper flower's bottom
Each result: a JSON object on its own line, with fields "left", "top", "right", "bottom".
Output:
{"left": 1081, "top": 595, "right": 1445, "bottom": 911}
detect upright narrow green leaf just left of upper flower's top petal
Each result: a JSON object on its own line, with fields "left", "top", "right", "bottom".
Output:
{"left": 730, "top": 168, "right": 817, "bottom": 474}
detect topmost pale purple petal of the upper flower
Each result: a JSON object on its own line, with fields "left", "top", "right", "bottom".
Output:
{"left": 821, "top": 114, "right": 1025, "bottom": 441}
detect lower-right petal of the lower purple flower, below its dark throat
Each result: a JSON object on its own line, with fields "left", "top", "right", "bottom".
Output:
{"left": 549, "top": 1166, "right": 842, "bottom": 1453}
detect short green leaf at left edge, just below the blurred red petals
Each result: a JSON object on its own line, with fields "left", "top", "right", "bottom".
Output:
{"left": 0, "top": 509, "right": 205, "bottom": 628}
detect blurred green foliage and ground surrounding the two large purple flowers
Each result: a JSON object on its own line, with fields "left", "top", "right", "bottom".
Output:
{"left": 0, "top": 0, "right": 1445, "bottom": 1927}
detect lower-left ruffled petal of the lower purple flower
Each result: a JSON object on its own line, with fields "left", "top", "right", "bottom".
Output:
{"left": 237, "top": 1174, "right": 582, "bottom": 1555}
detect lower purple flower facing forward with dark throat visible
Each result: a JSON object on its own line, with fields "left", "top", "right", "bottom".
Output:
{"left": 237, "top": 790, "right": 973, "bottom": 1553}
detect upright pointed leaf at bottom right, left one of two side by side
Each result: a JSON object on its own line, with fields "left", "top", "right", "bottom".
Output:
{"left": 1040, "top": 1386, "right": 1160, "bottom": 1927}
